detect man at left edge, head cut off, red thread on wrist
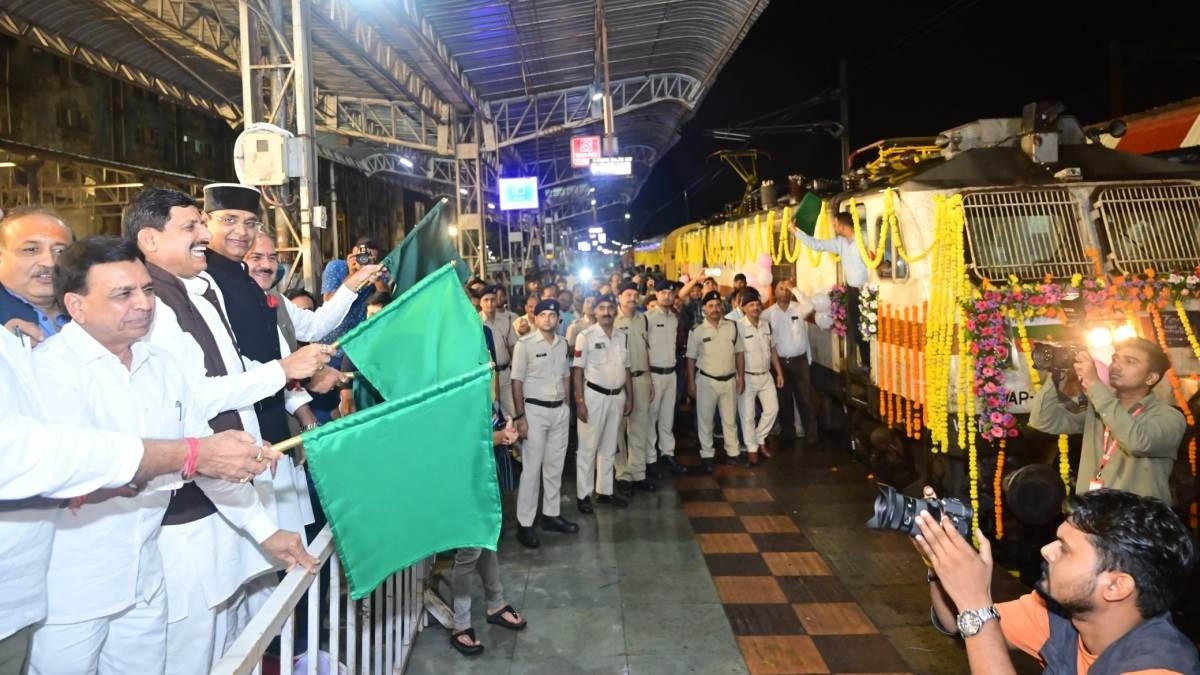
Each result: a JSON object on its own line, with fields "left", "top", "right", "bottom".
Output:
{"left": 0, "top": 330, "right": 271, "bottom": 674}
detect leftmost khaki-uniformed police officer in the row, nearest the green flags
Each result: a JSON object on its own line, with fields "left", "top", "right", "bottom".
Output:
{"left": 512, "top": 300, "right": 580, "bottom": 548}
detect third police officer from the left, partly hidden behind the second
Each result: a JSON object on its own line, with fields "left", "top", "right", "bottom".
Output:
{"left": 612, "top": 281, "right": 655, "bottom": 496}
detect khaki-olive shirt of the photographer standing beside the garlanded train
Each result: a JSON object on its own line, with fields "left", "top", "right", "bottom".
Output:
{"left": 1030, "top": 381, "right": 1187, "bottom": 503}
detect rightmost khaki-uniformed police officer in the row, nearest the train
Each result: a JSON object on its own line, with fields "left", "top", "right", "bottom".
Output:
{"left": 738, "top": 287, "right": 784, "bottom": 464}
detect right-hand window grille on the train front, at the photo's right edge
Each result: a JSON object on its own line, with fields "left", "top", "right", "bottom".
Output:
{"left": 1096, "top": 185, "right": 1200, "bottom": 274}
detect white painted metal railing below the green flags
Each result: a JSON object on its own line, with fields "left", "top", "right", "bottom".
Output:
{"left": 212, "top": 525, "right": 428, "bottom": 675}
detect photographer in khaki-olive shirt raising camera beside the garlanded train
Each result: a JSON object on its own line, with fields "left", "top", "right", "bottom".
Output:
{"left": 1030, "top": 338, "right": 1187, "bottom": 503}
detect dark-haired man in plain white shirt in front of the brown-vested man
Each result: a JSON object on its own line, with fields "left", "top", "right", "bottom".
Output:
{"left": 31, "top": 237, "right": 316, "bottom": 674}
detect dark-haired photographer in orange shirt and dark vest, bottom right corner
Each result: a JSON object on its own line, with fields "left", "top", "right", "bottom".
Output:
{"left": 914, "top": 488, "right": 1200, "bottom": 675}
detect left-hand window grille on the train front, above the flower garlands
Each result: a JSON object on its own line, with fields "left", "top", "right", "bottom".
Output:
{"left": 962, "top": 189, "right": 1092, "bottom": 280}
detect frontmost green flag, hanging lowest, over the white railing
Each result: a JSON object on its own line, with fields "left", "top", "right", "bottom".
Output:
{"left": 304, "top": 365, "right": 502, "bottom": 599}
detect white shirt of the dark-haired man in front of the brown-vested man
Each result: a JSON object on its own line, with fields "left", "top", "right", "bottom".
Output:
{"left": 34, "top": 323, "right": 276, "bottom": 623}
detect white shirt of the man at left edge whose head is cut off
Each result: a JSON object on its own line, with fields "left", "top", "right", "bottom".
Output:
{"left": 0, "top": 330, "right": 143, "bottom": 639}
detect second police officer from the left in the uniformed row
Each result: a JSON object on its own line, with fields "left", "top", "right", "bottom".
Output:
{"left": 571, "top": 294, "right": 634, "bottom": 513}
